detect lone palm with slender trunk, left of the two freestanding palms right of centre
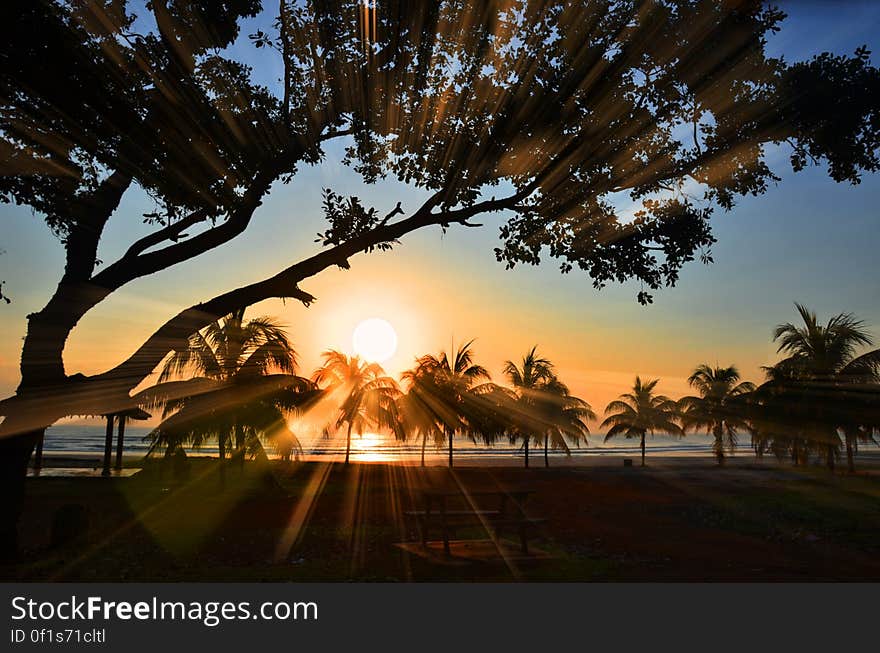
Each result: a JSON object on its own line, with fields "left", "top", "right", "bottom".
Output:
{"left": 601, "top": 376, "right": 684, "bottom": 467}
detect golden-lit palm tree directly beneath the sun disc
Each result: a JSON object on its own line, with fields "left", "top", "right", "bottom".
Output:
{"left": 312, "top": 350, "right": 400, "bottom": 465}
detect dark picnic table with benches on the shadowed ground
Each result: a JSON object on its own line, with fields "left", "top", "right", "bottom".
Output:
{"left": 406, "top": 488, "right": 546, "bottom": 556}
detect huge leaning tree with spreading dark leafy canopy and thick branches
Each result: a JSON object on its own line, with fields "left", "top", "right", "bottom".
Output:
{"left": 0, "top": 0, "right": 880, "bottom": 552}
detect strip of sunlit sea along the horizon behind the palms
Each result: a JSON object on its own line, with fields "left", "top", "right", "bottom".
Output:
{"left": 43, "top": 424, "right": 751, "bottom": 461}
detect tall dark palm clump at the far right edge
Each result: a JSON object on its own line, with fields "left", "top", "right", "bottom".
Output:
{"left": 762, "top": 303, "right": 880, "bottom": 471}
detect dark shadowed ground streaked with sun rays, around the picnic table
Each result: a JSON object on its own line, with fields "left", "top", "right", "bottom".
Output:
{"left": 0, "top": 460, "right": 880, "bottom": 581}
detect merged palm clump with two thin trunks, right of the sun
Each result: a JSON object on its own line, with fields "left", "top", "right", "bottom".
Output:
{"left": 504, "top": 345, "right": 596, "bottom": 467}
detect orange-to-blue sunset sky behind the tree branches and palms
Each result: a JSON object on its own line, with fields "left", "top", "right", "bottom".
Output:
{"left": 0, "top": 3, "right": 880, "bottom": 428}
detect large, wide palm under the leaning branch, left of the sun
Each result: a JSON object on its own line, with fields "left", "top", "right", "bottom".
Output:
{"left": 134, "top": 309, "right": 316, "bottom": 479}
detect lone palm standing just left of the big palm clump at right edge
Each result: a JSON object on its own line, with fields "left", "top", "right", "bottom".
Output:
{"left": 678, "top": 363, "right": 755, "bottom": 465}
